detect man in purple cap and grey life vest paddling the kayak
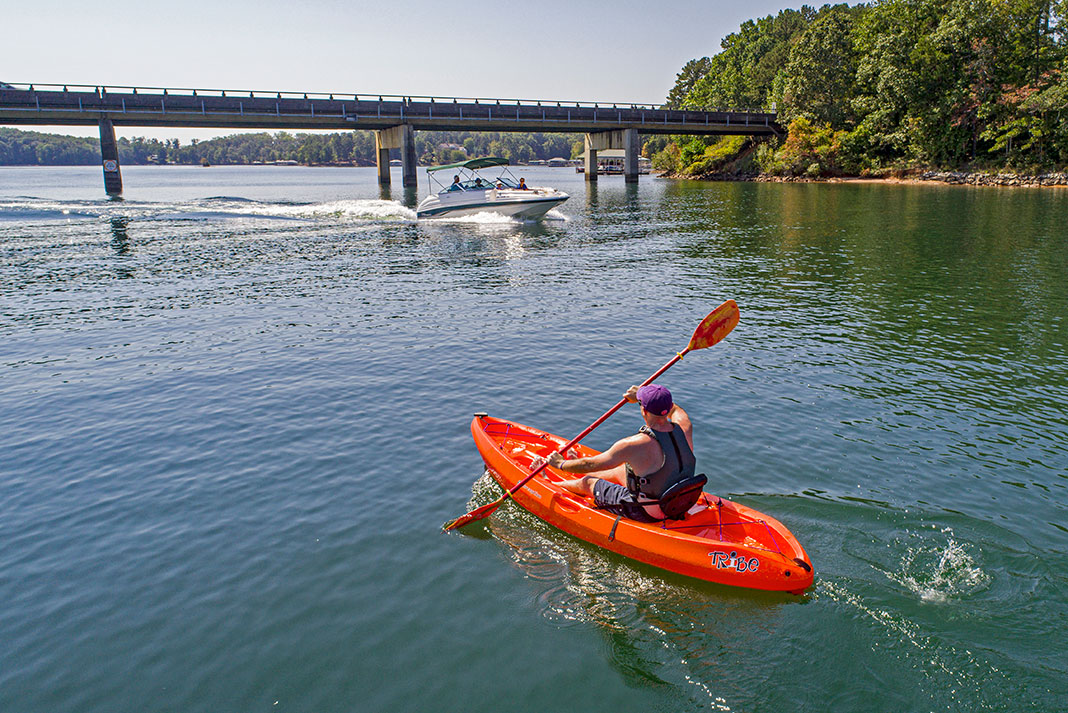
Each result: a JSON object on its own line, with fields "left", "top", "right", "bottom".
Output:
{"left": 534, "top": 384, "right": 696, "bottom": 522}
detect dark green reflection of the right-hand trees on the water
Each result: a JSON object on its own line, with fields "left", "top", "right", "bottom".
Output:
{"left": 665, "top": 181, "right": 1068, "bottom": 355}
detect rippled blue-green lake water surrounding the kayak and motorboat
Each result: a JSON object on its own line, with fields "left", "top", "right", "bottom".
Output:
{"left": 0, "top": 167, "right": 1068, "bottom": 713}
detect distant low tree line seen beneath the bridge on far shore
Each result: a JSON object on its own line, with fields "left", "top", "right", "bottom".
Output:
{"left": 0, "top": 128, "right": 582, "bottom": 165}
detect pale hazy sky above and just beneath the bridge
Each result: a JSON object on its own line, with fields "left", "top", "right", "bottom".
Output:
{"left": 6, "top": 0, "right": 801, "bottom": 141}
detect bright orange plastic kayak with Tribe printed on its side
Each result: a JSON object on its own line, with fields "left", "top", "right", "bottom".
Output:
{"left": 471, "top": 414, "right": 814, "bottom": 593}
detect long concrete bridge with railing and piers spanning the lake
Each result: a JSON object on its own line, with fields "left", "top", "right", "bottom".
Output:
{"left": 0, "top": 84, "right": 783, "bottom": 195}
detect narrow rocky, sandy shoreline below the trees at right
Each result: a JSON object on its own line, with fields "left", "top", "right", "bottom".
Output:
{"left": 659, "top": 171, "right": 1068, "bottom": 188}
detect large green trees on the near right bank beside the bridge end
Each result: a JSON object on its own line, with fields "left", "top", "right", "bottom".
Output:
{"left": 646, "top": 0, "right": 1068, "bottom": 175}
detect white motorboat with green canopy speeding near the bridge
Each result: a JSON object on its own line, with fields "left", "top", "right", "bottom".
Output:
{"left": 415, "top": 157, "right": 568, "bottom": 220}
